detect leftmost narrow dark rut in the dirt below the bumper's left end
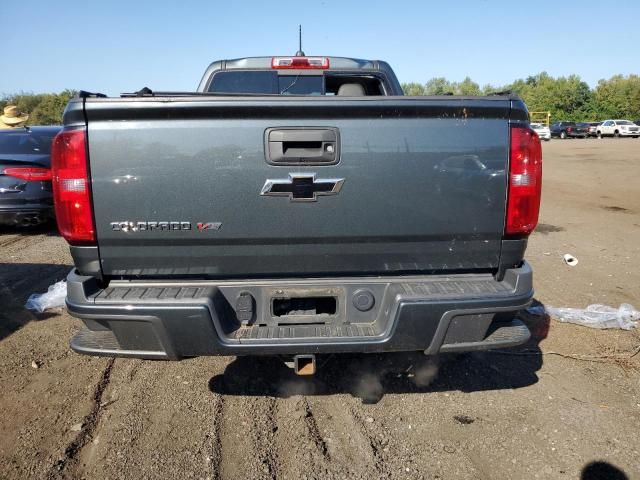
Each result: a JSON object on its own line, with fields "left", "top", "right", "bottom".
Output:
{"left": 47, "top": 358, "right": 115, "bottom": 479}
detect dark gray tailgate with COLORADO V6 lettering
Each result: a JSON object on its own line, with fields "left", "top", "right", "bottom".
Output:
{"left": 84, "top": 97, "right": 510, "bottom": 278}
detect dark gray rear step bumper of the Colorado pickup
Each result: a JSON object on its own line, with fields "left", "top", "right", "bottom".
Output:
{"left": 67, "top": 263, "right": 533, "bottom": 360}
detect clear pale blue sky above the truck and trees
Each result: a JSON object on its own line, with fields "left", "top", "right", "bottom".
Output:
{"left": 0, "top": 0, "right": 640, "bottom": 95}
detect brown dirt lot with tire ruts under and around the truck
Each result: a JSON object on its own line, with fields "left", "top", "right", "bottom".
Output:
{"left": 0, "top": 139, "right": 640, "bottom": 479}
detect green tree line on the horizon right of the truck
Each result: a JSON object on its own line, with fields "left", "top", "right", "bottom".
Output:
{"left": 402, "top": 72, "right": 640, "bottom": 122}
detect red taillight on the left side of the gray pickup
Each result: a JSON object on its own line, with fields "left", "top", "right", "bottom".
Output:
{"left": 51, "top": 130, "right": 96, "bottom": 245}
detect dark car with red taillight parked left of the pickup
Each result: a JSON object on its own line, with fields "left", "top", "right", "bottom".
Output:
{"left": 0, "top": 127, "right": 61, "bottom": 226}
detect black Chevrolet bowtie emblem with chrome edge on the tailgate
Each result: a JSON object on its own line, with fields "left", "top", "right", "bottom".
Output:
{"left": 260, "top": 173, "right": 344, "bottom": 202}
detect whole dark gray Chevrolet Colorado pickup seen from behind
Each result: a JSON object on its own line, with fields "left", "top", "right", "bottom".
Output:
{"left": 53, "top": 57, "right": 542, "bottom": 373}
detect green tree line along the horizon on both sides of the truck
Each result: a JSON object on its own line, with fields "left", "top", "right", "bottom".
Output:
{"left": 0, "top": 72, "right": 640, "bottom": 125}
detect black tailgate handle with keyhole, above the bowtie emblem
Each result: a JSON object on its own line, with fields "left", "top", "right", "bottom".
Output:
{"left": 265, "top": 127, "right": 340, "bottom": 165}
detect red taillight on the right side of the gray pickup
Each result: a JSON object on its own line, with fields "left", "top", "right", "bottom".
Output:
{"left": 505, "top": 125, "right": 542, "bottom": 235}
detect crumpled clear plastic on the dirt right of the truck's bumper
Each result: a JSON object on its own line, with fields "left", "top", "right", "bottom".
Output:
{"left": 527, "top": 303, "right": 640, "bottom": 330}
